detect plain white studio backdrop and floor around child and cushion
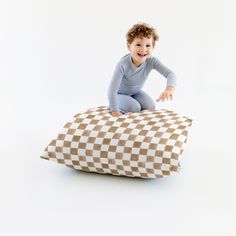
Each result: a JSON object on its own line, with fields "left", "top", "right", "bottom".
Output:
{"left": 0, "top": 0, "right": 236, "bottom": 236}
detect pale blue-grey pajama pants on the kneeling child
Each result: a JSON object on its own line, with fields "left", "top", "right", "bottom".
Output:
{"left": 118, "top": 90, "right": 155, "bottom": 113}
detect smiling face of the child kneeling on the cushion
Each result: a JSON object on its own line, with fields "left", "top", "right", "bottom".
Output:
{"left": 128, "top": 37, "right": 153, "bottom": 66}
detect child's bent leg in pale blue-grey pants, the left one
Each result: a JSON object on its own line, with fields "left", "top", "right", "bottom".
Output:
{"left": 118, "top": 94, "right": 141, "bottom": 113}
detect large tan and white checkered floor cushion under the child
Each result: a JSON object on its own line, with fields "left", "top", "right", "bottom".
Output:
{"left": 41, "top": 106, "right": 192, "bottom": 178}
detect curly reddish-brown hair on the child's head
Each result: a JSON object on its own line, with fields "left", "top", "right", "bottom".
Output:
{"left": 126, "top": 23, "right": 159, "bottom": 47}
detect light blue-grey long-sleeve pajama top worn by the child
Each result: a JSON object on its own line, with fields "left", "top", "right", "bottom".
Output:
{"left": 108, "top": 54, "right": 176, "bottom": 111}
